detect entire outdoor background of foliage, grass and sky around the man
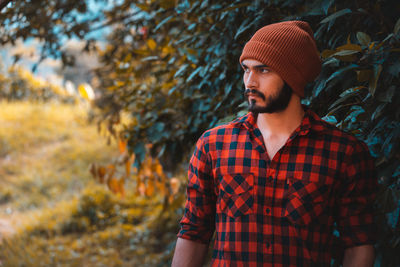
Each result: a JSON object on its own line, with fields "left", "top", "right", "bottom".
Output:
{"left": 0, "top": 0, "right": 400, "bottom": 266}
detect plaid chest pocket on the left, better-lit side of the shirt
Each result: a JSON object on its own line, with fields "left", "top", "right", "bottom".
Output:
{"left": 217, "top": 173, "right": 254, "bottom": 220}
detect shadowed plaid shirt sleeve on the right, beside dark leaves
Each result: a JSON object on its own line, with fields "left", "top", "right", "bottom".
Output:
{"left": 337, "top": 142, "right": 378, "bottom": 248}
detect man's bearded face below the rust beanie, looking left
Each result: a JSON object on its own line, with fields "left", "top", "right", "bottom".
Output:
{"left": 242, "top": 59, "right": 292, "bottom": 113}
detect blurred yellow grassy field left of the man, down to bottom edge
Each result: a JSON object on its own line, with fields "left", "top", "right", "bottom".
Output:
{"left": 0, "top": 102, "right": 182, "bottom": 266}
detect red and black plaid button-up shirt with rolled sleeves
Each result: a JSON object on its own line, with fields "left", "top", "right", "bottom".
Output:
{"left": 178, "top": 109, "right": 377, "bottom": 267}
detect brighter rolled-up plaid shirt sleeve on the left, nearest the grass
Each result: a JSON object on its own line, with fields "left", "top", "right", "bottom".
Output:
{"left": 177, "top": 136, "right": 216, "bottom": 244}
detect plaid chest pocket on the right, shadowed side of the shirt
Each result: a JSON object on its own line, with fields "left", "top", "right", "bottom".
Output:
{"left": 282, "top": 178, "right": 331, "bottom": 225}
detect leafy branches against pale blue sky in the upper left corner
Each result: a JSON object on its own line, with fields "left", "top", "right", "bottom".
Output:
{"left": 0, "top": 0, "right": 103, "bottom": 65}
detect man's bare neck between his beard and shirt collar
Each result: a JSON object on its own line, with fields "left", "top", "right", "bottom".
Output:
{"left": 257, "top": 94, "right": 304, "bottom": 138}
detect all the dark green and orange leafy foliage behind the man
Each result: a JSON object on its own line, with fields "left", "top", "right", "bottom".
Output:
{"left": 0, "top": 0, "right": 400, "bottom": 266}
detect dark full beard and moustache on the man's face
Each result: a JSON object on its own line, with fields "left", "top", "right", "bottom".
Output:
{"left": 244, "top": 83, "right": 293, "bottom": 114}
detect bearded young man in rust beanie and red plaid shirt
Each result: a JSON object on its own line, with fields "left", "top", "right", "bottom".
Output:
{"left": 172, "top": 21, "right": 377, "bottom": 267}
